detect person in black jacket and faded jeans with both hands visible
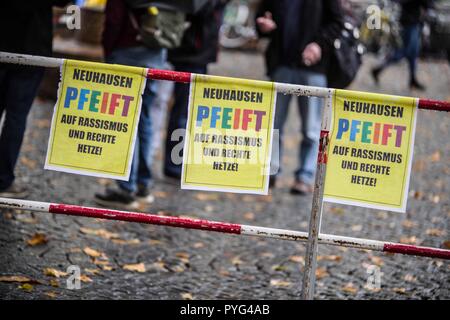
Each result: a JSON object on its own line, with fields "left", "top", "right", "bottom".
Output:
{"left": 256, "top": 0, "right": 343, "bottom": 194}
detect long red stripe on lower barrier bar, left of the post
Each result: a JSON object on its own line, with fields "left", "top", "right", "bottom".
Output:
{"left": 49, "top": 204, "right": 241, "bottom": 234}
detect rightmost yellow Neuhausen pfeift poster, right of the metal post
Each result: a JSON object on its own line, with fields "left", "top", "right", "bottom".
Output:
{"left": 324, "top": 90, "right": 417, "bottom": 212}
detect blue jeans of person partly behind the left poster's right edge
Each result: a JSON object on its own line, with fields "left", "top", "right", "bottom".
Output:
{"left": 105, "top": 47, "right": 166, "bottom": 192}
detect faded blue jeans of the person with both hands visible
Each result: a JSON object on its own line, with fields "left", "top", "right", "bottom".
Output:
{"left": 271, "top": 66, "right": 327, "bottom": 183}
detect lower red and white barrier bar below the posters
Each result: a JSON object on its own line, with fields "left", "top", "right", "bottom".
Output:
{"left": 0, "top": 198, "right": 450, "bottom": 260}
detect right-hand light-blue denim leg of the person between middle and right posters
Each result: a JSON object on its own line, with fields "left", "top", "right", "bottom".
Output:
{"left": 295, "top": 70, "right": 327, "bottom": 193}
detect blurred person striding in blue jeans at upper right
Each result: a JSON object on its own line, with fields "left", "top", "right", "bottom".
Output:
{"left": 372, "top": 0, "right": 433, "bottom": 90}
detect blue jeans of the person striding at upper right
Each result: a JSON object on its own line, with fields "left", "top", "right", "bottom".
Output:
{"left": 383, "top": 23, "right": 422, "bottom": 79}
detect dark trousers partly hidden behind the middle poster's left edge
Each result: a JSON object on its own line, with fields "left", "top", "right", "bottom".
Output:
{"left": 164, "top": 65, "right": 206, "bottom": 177}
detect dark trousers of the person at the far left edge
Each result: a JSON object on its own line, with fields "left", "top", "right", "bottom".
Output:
{"left": 0, "top": 66, "right": 44, "bottom": 190}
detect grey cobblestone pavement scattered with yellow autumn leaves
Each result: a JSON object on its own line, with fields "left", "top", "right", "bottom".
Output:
{"left": 0, "top": 52, "right": 450, "bottom": 299}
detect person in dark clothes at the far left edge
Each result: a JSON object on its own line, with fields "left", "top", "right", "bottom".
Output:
{"left": 0, "top": 0, "right": 70, "bottom": 198}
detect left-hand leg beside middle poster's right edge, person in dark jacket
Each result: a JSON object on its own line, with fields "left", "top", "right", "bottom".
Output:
{"left": 270, "top": 67, "right": 293, "bottom": 181}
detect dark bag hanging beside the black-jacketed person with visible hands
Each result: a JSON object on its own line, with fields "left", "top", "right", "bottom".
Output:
{"left": 327, "top": 22, "right": 364, "bottom": 89}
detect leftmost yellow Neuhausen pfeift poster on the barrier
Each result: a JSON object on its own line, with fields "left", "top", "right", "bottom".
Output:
{"left": 45, "top": 60, "right": 146, "bottom": 180}
